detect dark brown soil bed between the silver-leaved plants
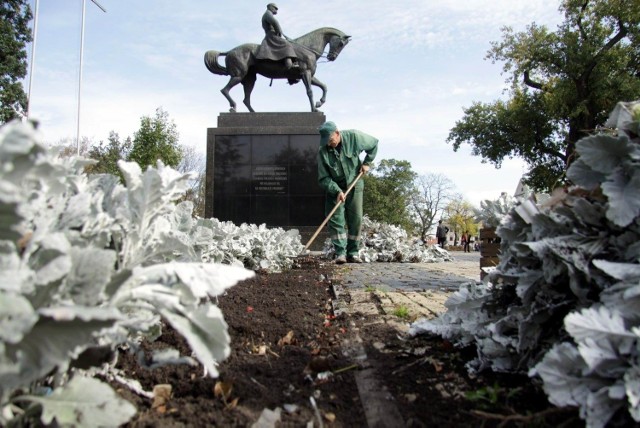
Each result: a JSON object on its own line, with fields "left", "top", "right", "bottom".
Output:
{"left": 114, "top": 258, "right": 583, "bottom": 427}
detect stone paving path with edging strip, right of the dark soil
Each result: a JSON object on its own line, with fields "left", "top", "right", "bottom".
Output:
{"left": 332, "top": 252, "right": 480, "bottom": 428}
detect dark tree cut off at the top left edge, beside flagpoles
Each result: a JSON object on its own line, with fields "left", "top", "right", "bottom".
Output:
{"left": 0, "top": 0, "right": 32, "bottom": 123}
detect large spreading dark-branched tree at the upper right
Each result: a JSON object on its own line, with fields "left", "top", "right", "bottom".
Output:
{"left": 447, "top": 0, "right": 640, "bottom": 191}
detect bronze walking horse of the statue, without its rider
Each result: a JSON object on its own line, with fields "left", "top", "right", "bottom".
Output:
{"left": 204, "top": 27, "right": 351, "bottom": 112}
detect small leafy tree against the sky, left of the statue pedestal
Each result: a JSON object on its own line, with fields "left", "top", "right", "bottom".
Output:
{"left": 128, "top": 108, "right": 182, "bottom": 170}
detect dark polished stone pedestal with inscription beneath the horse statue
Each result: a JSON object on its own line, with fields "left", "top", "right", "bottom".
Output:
{"left": 205, "top": 112, "right": 327, "bottom": 250}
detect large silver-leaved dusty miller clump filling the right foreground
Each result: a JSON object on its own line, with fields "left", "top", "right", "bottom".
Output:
{"left": 411, "top": 102, "right": 640, "bottom": 427}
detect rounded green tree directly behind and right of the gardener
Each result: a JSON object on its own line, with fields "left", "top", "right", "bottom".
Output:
{"left": 363, "top": 159, "right": 417, "bottom": 233}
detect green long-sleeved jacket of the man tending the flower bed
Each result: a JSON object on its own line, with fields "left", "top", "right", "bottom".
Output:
{"left": 318, "top": 129, "right": 378, "bottom": 195}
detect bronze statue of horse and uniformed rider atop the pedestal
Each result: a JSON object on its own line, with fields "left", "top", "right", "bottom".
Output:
{"left": 204, "top": 3, "right": 351, "bottom": 113}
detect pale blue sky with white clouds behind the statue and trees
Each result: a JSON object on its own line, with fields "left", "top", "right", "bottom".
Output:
{"left": 25, "top": 0, "right": 562, "bottom": 205}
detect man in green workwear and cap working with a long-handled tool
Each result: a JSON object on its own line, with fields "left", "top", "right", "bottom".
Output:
{"left": 318, "top": 118, "right": 378, "bottom": 264}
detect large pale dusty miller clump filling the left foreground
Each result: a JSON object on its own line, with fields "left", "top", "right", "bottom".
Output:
{"left": 0, "top": 123, "right": 253, "bottom": 426}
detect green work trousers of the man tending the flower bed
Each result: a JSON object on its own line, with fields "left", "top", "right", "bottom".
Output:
{"left": 325, "top": 187, "right": 363, "bottom": 256}
